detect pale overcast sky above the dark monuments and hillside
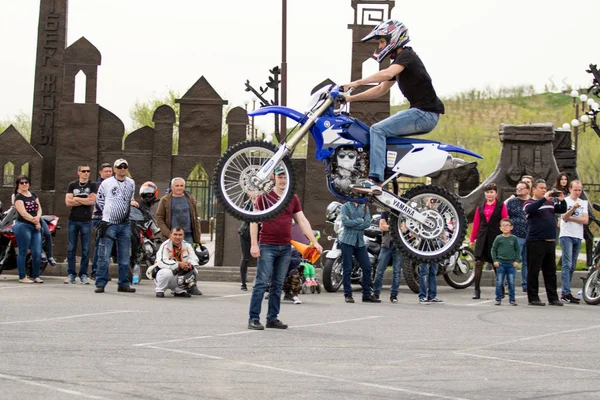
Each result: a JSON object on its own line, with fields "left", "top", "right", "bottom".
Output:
{"left": 0, "top": 0, "right": 600, "bottom": 130}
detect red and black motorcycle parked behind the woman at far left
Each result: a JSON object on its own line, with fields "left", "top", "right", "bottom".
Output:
{"left": 0, "top": 202, "right": 58, "bottom": 276}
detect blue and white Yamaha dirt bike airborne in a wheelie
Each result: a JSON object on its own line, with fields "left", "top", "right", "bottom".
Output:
{"left": 213, "top": 85, "right": 482, "bottom": 262}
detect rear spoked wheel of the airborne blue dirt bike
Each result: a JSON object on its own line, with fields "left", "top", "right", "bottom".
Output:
{"left": 390, "top": 185, "right": 467, "bottom": 263}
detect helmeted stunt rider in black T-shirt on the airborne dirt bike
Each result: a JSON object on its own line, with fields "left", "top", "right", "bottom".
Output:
{"left": 344, "top": 19, "right": 444, "bottom": 195}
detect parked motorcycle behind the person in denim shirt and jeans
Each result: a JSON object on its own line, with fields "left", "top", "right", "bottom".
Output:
{"left": 321, "top": 202, "right": 382, "bottom": 292}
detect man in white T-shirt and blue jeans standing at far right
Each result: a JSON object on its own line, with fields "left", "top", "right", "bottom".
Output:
{"left": 560, "top": 179, "right": 589, "bottom": 304}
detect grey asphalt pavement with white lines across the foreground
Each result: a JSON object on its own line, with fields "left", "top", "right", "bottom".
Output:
{"left": 0, "top": 275, "right": 600, "bottom": 400}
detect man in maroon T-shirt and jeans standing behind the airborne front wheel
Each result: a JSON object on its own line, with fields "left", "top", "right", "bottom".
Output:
{"left": 248, "top": 166, "right": 323, "bottom": 330}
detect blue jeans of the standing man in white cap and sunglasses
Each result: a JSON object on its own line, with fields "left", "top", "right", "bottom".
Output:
{"left": 96, "top": 222, "right": 131, "bottom": 287}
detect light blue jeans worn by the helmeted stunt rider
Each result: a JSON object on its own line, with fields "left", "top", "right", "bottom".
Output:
{"left": 369, "top": 108, "right": 440, "bottom": 181}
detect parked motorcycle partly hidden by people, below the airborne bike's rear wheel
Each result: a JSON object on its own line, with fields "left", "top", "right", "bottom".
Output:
{"left": 402, "top": 244, "right": 475, "bottom": 293}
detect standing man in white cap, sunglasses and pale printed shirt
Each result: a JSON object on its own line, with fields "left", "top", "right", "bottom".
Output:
{"left": 95, "top": 158, "right": 138, "bottom": 293}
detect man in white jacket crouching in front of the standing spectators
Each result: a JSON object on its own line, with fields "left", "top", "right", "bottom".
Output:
{"left": 154, "top": 227, "right": 200, "bottom": 298}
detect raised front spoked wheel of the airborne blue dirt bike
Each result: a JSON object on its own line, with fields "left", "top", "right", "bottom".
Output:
{"left": 213, "top": 140, "right": 296, "bottom": 222}
